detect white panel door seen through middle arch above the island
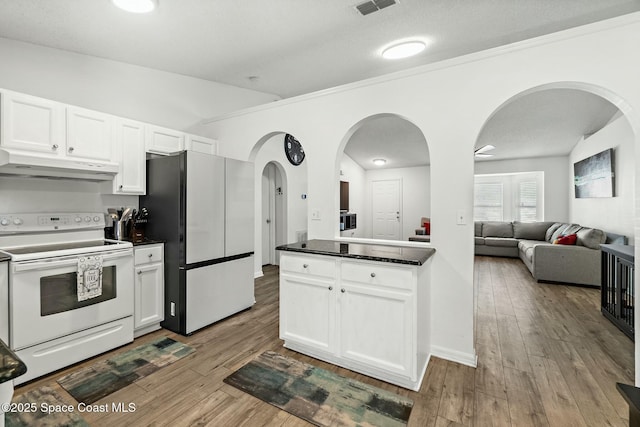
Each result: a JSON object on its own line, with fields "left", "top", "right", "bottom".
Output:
{"left": 371, "top": 179, "right": 402, "bottom": 240}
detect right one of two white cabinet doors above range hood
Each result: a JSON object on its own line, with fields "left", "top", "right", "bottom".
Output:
{"left": 66, "top": 107, "right": 114, "bottom": 161}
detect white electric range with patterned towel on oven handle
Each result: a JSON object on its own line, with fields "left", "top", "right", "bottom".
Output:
{"left": 0, "top": 212, "right": 134, "bottom": 384}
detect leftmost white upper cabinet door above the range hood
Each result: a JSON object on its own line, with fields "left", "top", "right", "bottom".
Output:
{"left": 0, "top": 92, "right": 65, "bottom": 155}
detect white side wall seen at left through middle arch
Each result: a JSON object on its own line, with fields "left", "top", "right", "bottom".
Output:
{"left": 336, "top": 154, "right": 364, "bottom": 237}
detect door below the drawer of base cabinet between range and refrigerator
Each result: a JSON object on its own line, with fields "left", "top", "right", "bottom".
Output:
{"left": 133, "top": 263, "right": 164, "bottom": 329}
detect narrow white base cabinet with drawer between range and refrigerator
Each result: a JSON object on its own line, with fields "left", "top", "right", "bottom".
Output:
{"left": 133, "top": 243, "right": 164, "bottom": 337}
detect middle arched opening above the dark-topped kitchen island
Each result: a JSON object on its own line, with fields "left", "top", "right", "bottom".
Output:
{"left": 336, "top": 113, "right": 431, "bottom": 244}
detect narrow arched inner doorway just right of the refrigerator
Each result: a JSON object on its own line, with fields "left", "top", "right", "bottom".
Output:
{"left": 261, "top": 162, "right": 284, "bottom": 265}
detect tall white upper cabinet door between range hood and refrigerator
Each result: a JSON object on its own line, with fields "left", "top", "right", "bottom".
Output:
{"left": 113, "top": 119, "right": 146, "bottom": 194}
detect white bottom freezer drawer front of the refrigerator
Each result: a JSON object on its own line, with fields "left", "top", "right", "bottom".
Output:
{"left": 186, "top": 255, "right": 255, "bottom": 334}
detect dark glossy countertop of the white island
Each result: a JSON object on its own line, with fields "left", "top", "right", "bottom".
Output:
{"left": 276, "top": 240, "right": 436, "bottom": 265}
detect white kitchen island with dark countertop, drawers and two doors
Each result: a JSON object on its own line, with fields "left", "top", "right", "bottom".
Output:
{"left": 276, "top": 240, "right": 435, "bottom": 390}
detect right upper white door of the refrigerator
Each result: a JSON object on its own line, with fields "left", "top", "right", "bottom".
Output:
{"left": 224, "top": 159, "right": 255, "bottom": 256}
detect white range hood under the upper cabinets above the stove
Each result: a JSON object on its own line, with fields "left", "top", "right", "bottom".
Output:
{"left": 0, "top": 148, "right": 119, "bottom": 181}
